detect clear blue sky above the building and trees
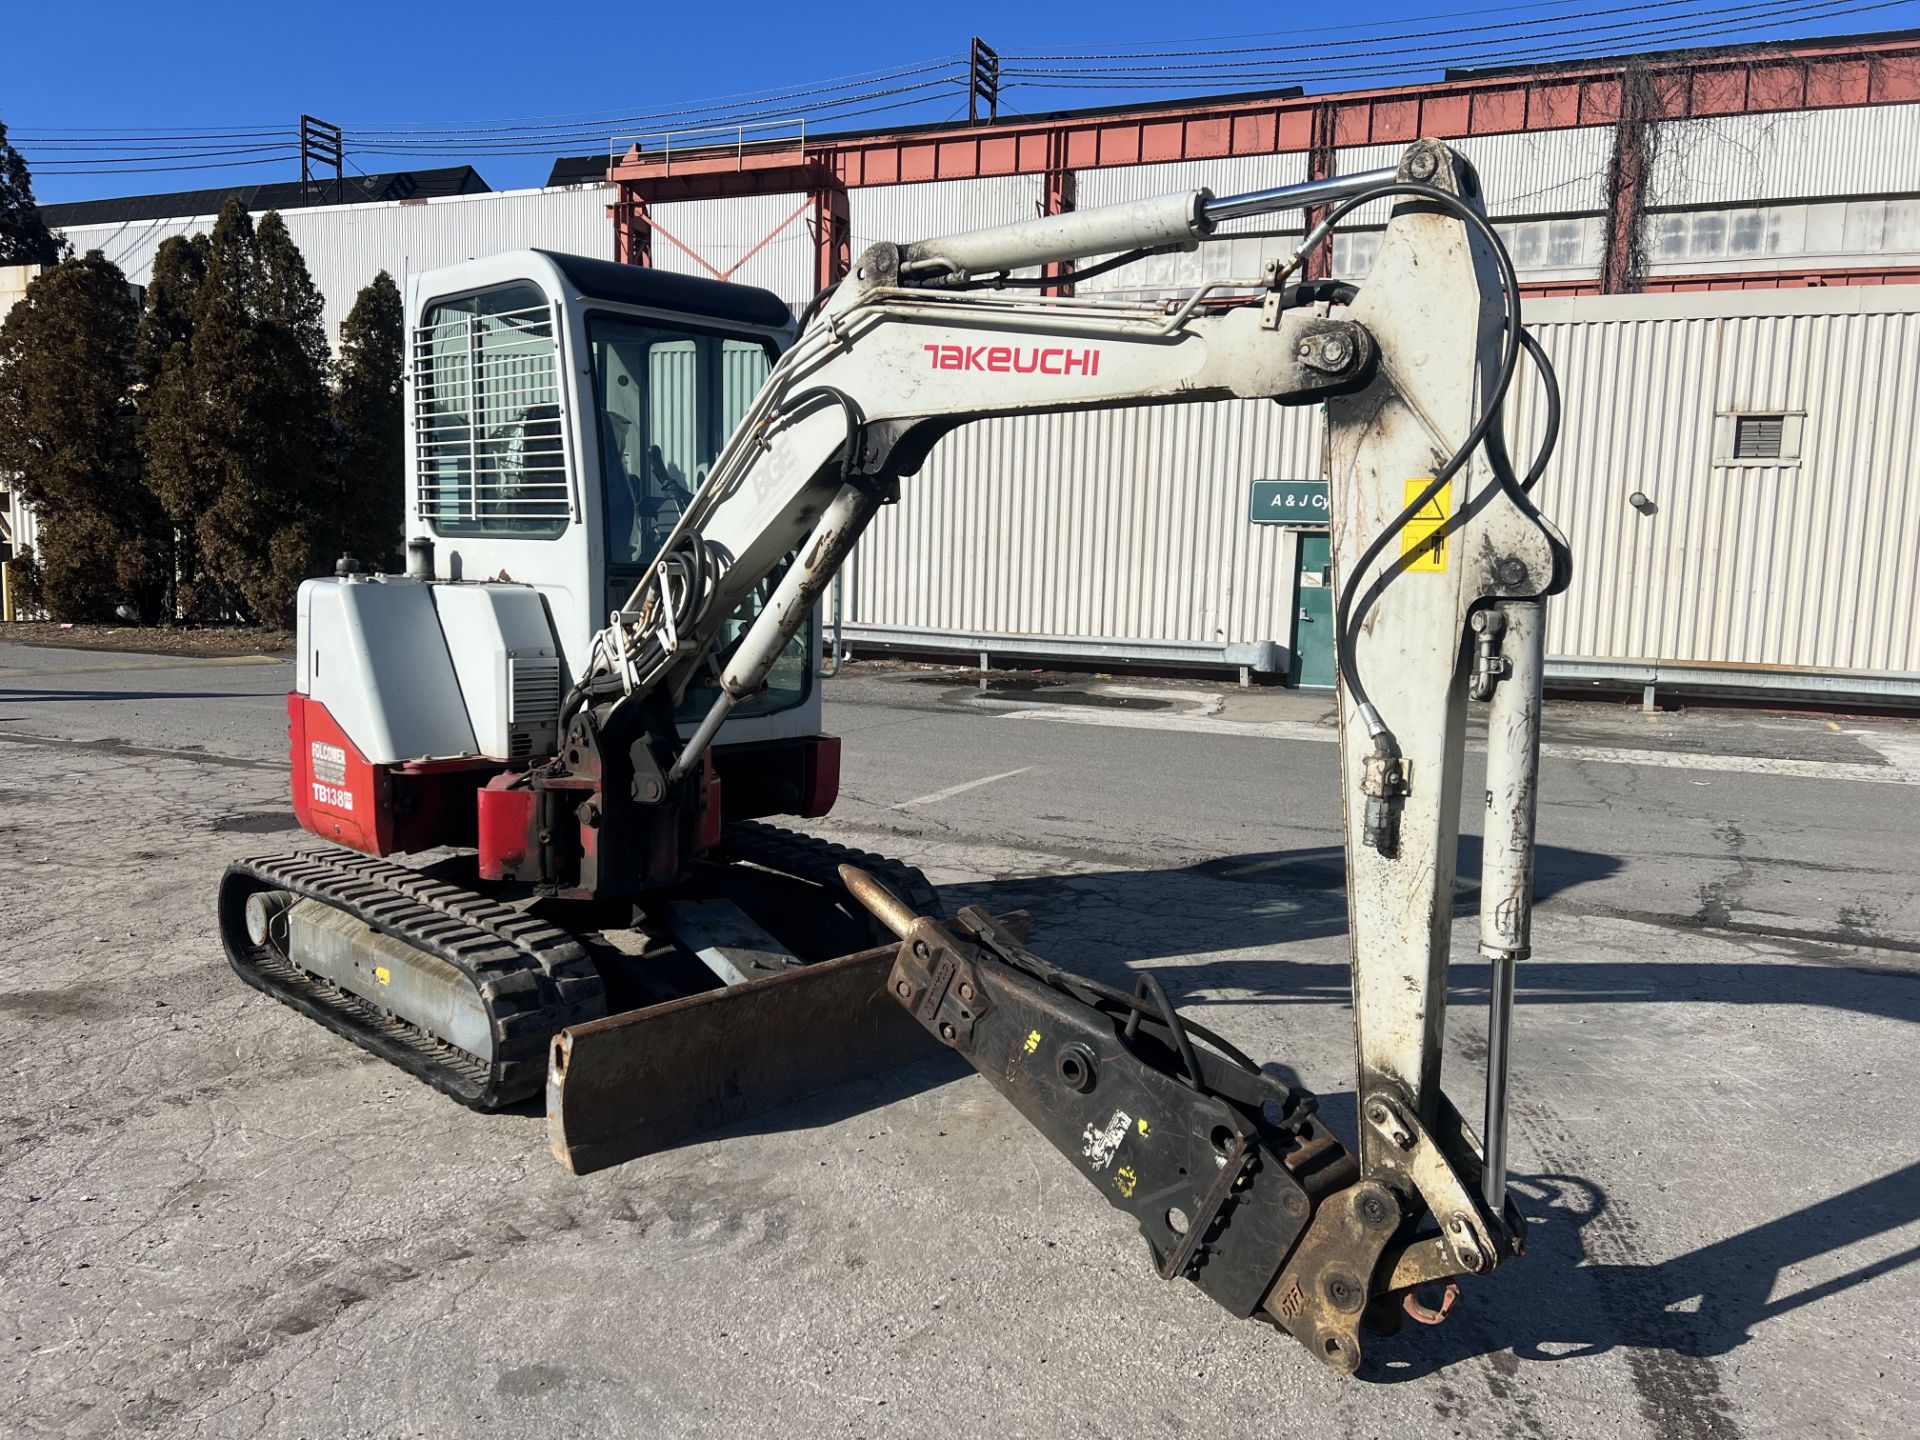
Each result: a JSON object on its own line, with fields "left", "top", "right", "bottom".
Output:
{"left": 0, "top": 0, "right": 1920, "bottom": 202}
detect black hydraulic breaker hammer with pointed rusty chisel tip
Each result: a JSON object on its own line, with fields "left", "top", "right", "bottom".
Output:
{"left": 841, "top": 866, "right": 1402, "bottom": 1371}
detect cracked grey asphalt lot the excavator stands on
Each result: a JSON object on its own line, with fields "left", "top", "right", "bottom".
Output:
{"left": 0, "top": 645, "right": 1920, "bottom": 1440}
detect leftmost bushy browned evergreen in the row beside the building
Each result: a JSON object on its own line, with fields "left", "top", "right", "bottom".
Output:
{"left": 0, "top": 250, "right": 171, "bottom": 620}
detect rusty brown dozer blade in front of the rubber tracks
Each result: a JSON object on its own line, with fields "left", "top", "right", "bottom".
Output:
{"left": 547, "top": 945, "right": 943, "bottom": 1175}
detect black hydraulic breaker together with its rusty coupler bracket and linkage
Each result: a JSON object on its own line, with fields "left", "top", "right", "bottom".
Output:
{"left": 841, "top": 866, "right": 1521, "bottom": 1375}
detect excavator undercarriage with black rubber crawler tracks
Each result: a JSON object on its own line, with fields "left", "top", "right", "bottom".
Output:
{"left": 219, "top": 822, "right": 935, "bottom": 1113}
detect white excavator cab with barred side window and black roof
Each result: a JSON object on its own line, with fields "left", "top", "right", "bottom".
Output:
{"left": 407, "top": 250, "right": 820, "bottom": 743}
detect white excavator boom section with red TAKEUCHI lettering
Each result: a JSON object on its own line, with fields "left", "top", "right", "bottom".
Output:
{"left": 564, "top": 204, "right": 1375, "bottom": 737}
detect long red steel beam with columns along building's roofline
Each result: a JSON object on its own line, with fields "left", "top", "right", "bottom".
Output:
{"left": 609, "top": 35, "right": 1920, "bottom": 294}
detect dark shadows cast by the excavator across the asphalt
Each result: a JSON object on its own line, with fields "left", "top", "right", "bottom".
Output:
{"left": 641, "top": 837, "right": 1920, "bottom": 1390}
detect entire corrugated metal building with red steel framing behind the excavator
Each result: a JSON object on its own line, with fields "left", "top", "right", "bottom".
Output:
{"left": 26, "top": 35, "right": 1920, "bottom": 693}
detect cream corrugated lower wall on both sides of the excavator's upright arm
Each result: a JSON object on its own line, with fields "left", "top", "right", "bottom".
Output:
{"left": 847, "top": 286, "right": 1920, "bottom": 684}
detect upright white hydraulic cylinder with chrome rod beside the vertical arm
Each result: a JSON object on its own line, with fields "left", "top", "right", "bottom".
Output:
{"left": 1480, "top": 601, "right": 1546, "bottom": 1213}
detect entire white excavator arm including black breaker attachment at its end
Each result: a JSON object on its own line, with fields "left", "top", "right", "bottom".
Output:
{"left": 563, "top": 140, "right": 1569, "bottom": 1373}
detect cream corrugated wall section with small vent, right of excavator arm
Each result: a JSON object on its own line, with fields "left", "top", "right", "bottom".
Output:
{"left": 1523, "top": 286, "right": 1920, "bottom": 676}
